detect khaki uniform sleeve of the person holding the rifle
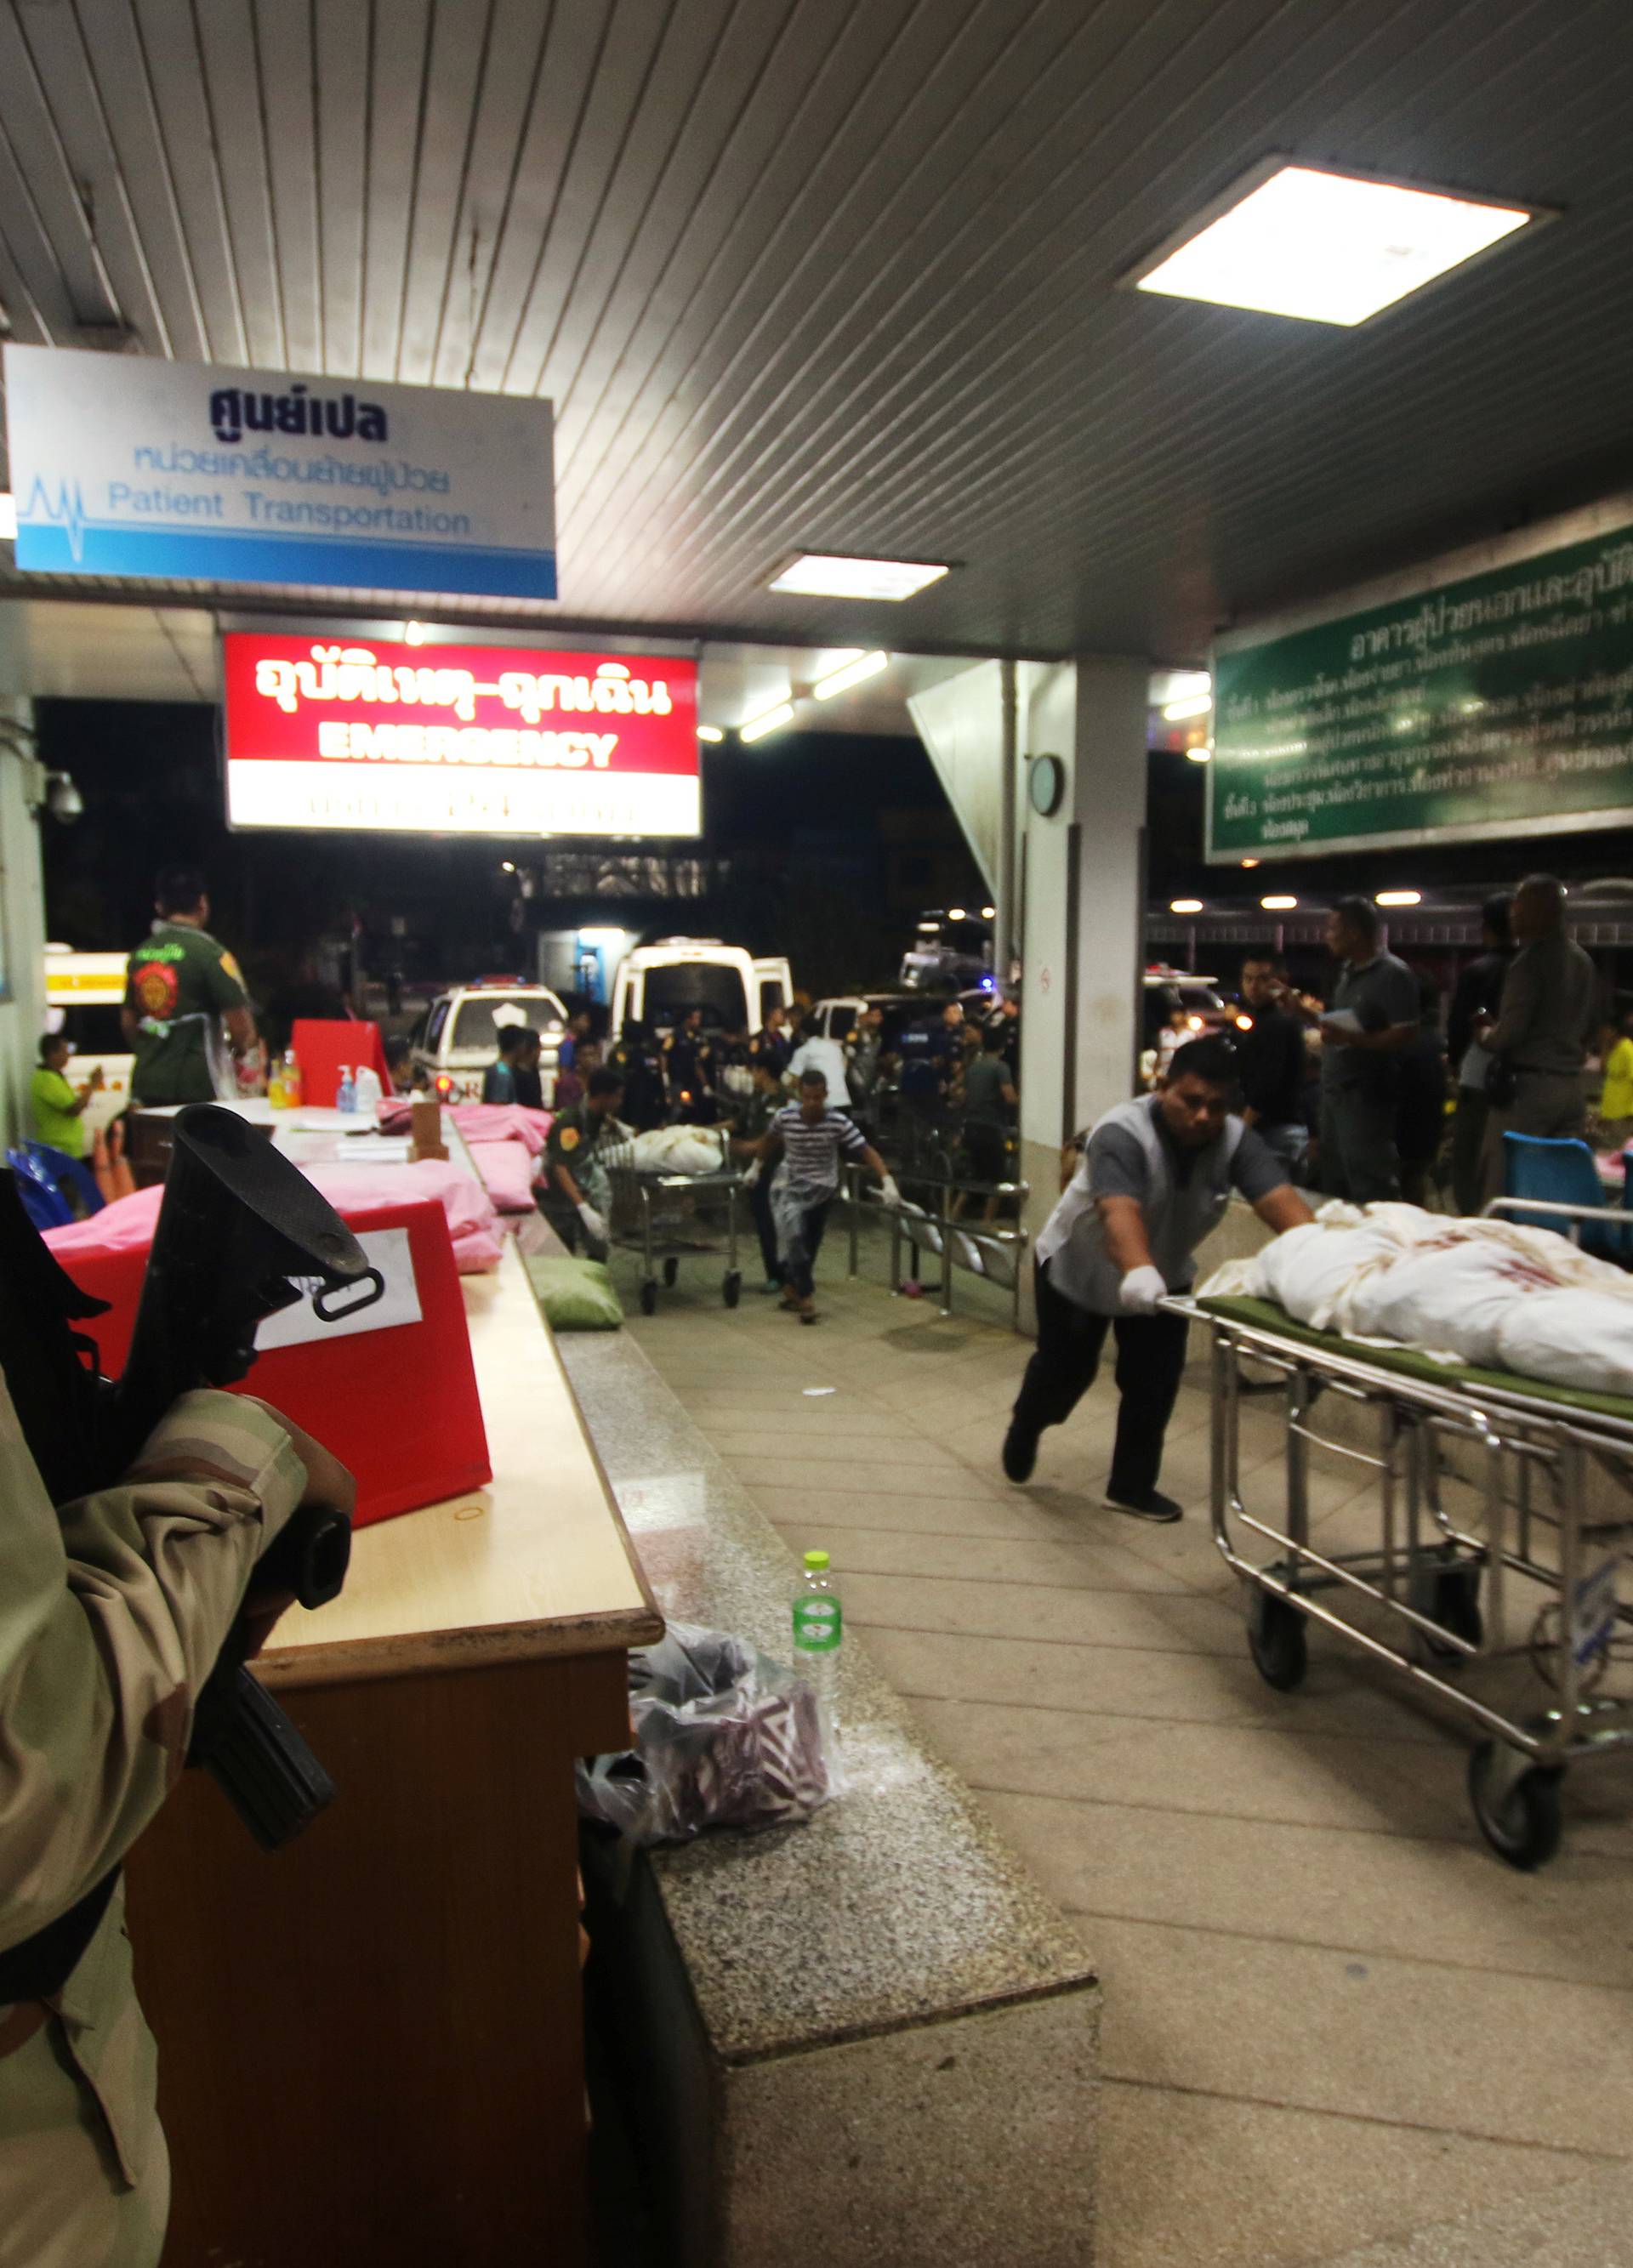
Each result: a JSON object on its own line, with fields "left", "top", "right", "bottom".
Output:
{"left": 0, "top": 1384, "right": 306, "bottom": 1948}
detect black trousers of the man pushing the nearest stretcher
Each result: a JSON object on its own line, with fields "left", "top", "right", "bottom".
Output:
{"left": 1014, "top": 1261, "right": 1188, "bottom": 1503}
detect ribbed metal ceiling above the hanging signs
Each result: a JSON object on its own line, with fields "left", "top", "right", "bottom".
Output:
{"left": 0, "top": 0, "right": 1633, "bottom": 660}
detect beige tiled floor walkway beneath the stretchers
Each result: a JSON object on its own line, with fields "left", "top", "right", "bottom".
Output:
{"left": 633, "top": 1254, "right": 1633, "bottom": 2268}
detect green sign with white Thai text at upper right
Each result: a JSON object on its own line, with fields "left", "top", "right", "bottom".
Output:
{"left": 1209, "top": 514, "right": 1633, "bottom": 861}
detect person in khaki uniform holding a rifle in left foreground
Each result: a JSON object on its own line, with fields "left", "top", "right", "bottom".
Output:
{"left": 0, "top": 1379, "right": 354, "bottom": 2268}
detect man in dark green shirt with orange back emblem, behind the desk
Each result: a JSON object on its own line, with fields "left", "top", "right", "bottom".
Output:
{"left": 120, "top": 867, "right": 256, "bottom": 1105}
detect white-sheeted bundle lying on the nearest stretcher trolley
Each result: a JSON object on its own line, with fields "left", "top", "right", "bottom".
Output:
{"left": 1198, "top": 1202, "right": 1633, "bottom": 1395}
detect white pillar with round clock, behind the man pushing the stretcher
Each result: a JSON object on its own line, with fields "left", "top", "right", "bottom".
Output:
{"left": 1021, "top": 656, "right": 1150, "bottom": 1260}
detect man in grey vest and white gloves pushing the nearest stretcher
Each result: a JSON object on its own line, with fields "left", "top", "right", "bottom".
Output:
{"left": 1003, "top": 1038, "right": 1311, "bottom": 1520}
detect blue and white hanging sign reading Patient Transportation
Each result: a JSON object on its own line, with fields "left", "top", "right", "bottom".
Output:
{"left": 4, "top": 347, "right": 555, "bottom": 599}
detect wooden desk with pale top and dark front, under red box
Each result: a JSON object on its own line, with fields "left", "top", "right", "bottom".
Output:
{"left": 129, "top": 1248, "right": 663, "bottom": 2268}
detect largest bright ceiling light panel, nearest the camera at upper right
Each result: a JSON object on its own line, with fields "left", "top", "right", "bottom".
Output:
{"left": 1125, "top": 156, "right": 1551, "bottom": 324}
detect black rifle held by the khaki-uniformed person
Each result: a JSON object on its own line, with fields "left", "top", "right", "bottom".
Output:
{"left": 0, "top": 1102, "right": 385, "bottom": 1850}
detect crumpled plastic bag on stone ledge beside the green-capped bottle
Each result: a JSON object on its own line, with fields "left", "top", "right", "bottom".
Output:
{"left": 578, "top": 1622, "right": 833, "bottom": 1844}
